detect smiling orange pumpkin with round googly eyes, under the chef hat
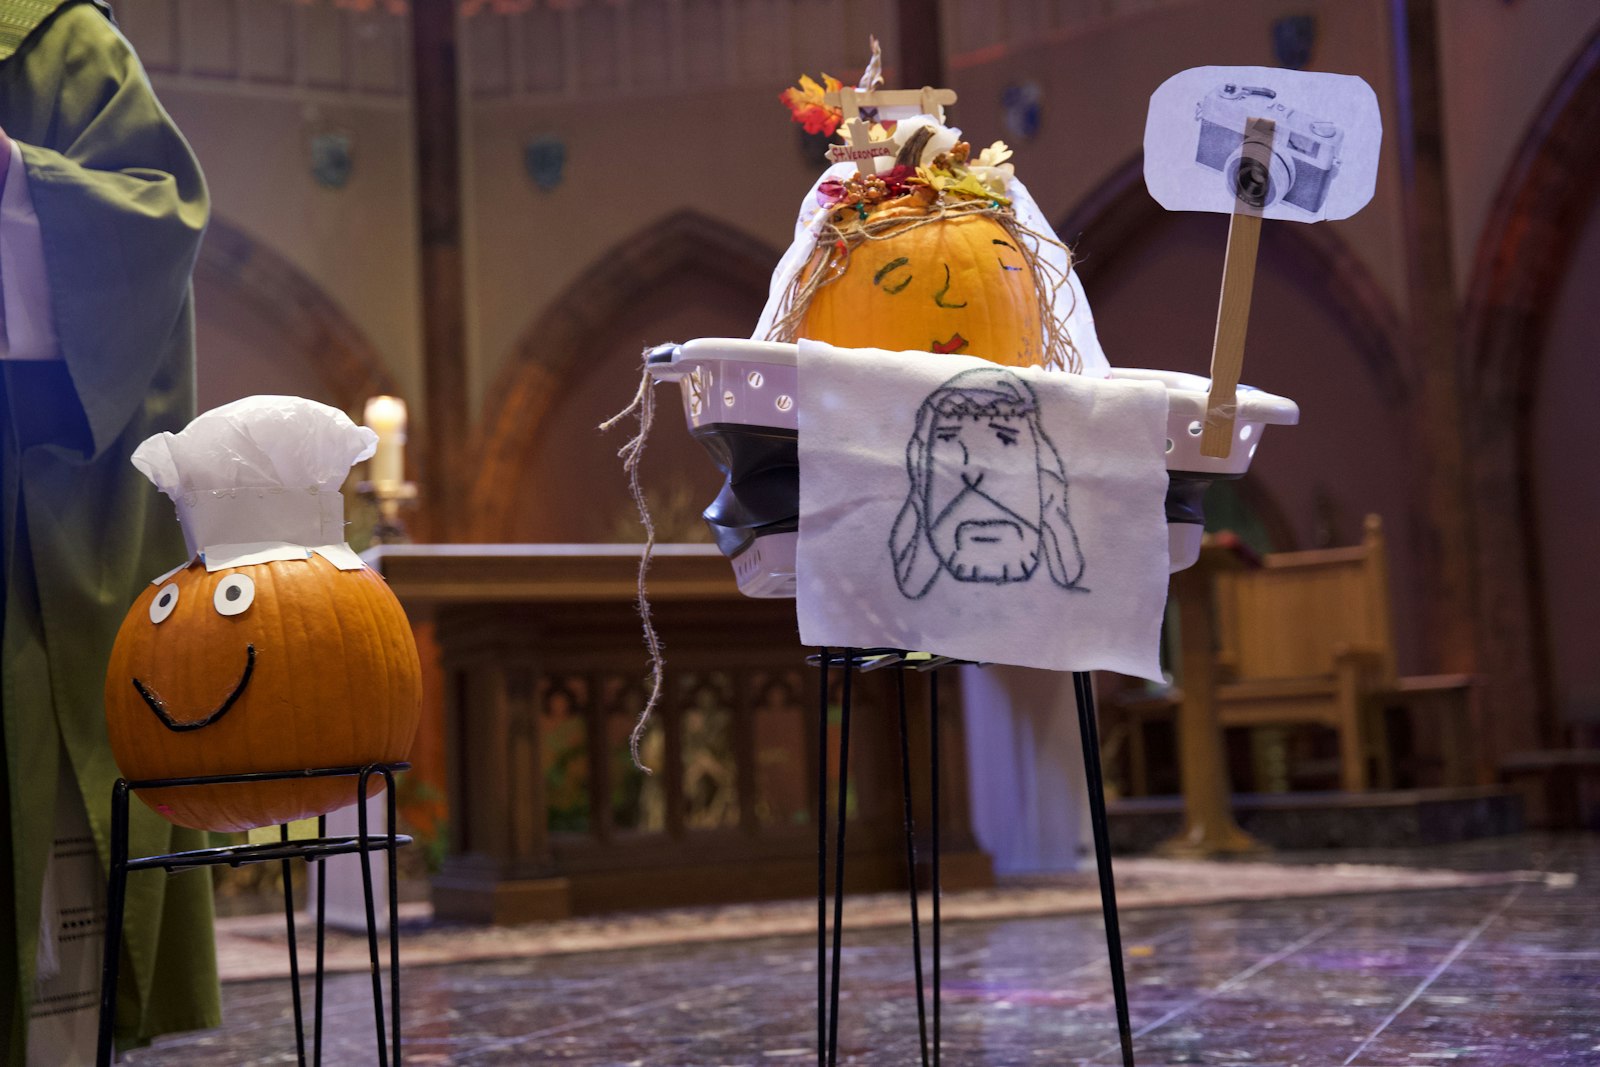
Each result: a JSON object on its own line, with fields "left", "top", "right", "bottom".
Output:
{"left": 106, "top": 555, "right": 422, "bottom": 830}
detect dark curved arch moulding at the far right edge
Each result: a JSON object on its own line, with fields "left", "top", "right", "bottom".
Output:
{"left": 1462, "top": 34, "right": 1600, "bottom": 753}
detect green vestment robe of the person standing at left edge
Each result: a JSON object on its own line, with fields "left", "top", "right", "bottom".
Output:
{"left": 0, "top": 0, "right": 219, "bottom": 1064}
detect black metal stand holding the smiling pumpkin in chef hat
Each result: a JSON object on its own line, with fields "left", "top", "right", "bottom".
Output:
{"left": 96, "top": 763, "right": 411, "bottom": 1067}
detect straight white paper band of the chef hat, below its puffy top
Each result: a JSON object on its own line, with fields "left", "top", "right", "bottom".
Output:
{"left": 178, "top": 486, "right": 344, "bottom": 569}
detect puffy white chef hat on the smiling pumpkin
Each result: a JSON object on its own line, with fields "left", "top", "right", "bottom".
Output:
{"left": 133, "top": 397, "right": 378, "bottom": 571}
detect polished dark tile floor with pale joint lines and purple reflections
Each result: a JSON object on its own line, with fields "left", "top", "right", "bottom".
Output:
{"left": 122, "top": 835, "right": 1600, "bottom": 1067}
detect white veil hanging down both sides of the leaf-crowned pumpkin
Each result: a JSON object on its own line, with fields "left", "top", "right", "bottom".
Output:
{"left": 750, "top": 115, "right": 1110, "bottom": 378}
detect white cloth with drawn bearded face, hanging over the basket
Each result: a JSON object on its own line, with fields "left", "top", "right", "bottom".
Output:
{"left": 795, "top": 341, "right": 1168, "bottom": 678}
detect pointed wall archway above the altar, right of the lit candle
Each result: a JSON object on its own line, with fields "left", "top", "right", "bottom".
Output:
{"left": 467, "top": 211, "right": 779, "bottom": 541}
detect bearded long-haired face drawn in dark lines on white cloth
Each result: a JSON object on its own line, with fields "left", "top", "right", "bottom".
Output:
{"left": 890, "top": 366, "right": 1083, "bottom": 600}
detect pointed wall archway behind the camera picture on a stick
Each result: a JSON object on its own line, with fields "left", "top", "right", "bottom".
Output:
{"left": 1058, "top": 157, "right": 1446, "bottom": 672}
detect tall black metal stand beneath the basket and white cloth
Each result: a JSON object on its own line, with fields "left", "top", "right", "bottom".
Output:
{"left": 810, "top": 648, "right": 1134, "bottom": 1067}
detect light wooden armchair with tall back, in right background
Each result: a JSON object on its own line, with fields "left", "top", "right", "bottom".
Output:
{"left": 1216, "top": 515, "right": 1474, "bottom": 790}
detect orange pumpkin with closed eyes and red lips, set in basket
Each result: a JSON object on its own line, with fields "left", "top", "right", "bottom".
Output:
{"left": 798, "top": 214, "right": 1045, "bottom": 366}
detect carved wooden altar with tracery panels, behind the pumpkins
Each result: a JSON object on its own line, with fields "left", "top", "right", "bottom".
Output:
{"left": 366, "top": 545, "right": 992, "bottom": 923}
